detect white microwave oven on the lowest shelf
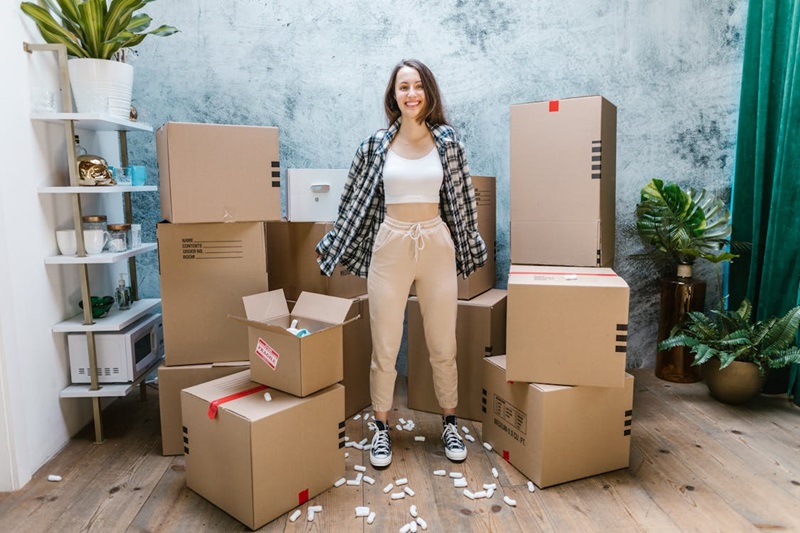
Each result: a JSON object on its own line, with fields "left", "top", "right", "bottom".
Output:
{"left": 67, "top": 313, "right": 164, "bottom": 383}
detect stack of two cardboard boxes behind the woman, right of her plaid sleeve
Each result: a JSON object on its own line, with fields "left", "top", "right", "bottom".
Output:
{"left": 407, "top": 176, "right": 506, "bottom": 420}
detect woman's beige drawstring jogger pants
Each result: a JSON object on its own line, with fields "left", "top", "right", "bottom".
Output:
{"left": 367, "top": 217, "right": 458, "bottom": 412}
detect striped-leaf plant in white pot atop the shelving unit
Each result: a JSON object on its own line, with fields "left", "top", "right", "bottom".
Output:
{"left": 20, "top": 0, "right": 178, "bottom": 118}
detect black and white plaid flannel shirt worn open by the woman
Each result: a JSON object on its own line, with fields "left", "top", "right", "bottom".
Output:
{"left": 316, "top": 119, "right": 488, "bottom": 277}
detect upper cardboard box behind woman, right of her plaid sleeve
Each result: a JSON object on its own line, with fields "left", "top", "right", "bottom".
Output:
{"left": 409, "top": 176, "right": 497, "bottom": 300}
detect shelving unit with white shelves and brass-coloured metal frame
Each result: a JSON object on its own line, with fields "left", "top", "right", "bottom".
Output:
{"left": 23, "top": 43, "right": 162, "bottom": 443}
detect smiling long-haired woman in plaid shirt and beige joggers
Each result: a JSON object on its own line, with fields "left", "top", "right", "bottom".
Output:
{"left": 317, "top": 59, "right": 487, "bottom": 467}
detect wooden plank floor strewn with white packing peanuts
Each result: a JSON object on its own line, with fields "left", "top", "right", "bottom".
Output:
{"left": 0, "top": 369, "right": 800, "bottom": 533}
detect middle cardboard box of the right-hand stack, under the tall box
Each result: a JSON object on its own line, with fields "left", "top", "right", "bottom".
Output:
{"left": 506, "top": 265, "right": 629, "bottom": 387}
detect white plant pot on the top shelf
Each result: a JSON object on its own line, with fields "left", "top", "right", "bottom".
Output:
{"left": 67, "top": 58, "right": 133, "bottom": 119}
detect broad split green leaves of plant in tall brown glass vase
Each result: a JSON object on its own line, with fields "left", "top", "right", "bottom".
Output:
{"left": 636, "top": 179, "right": 738, "bottom": 265}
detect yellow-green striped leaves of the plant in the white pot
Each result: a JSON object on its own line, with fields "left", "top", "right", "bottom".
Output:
{"left": 20, "top": 0, "right": 179, "bottom": 59}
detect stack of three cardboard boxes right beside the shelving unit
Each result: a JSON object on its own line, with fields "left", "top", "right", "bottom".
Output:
{"left": 156, "top": 122, "right": 281, "bottom": 455}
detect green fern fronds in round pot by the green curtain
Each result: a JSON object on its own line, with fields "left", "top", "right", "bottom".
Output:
{"left": 658, "top": 298, "right": 800, "bottom": 375}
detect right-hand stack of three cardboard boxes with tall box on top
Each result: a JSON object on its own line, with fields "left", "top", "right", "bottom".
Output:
{"left": 482, "top": 96, "right": 633, "bottom": 487}
